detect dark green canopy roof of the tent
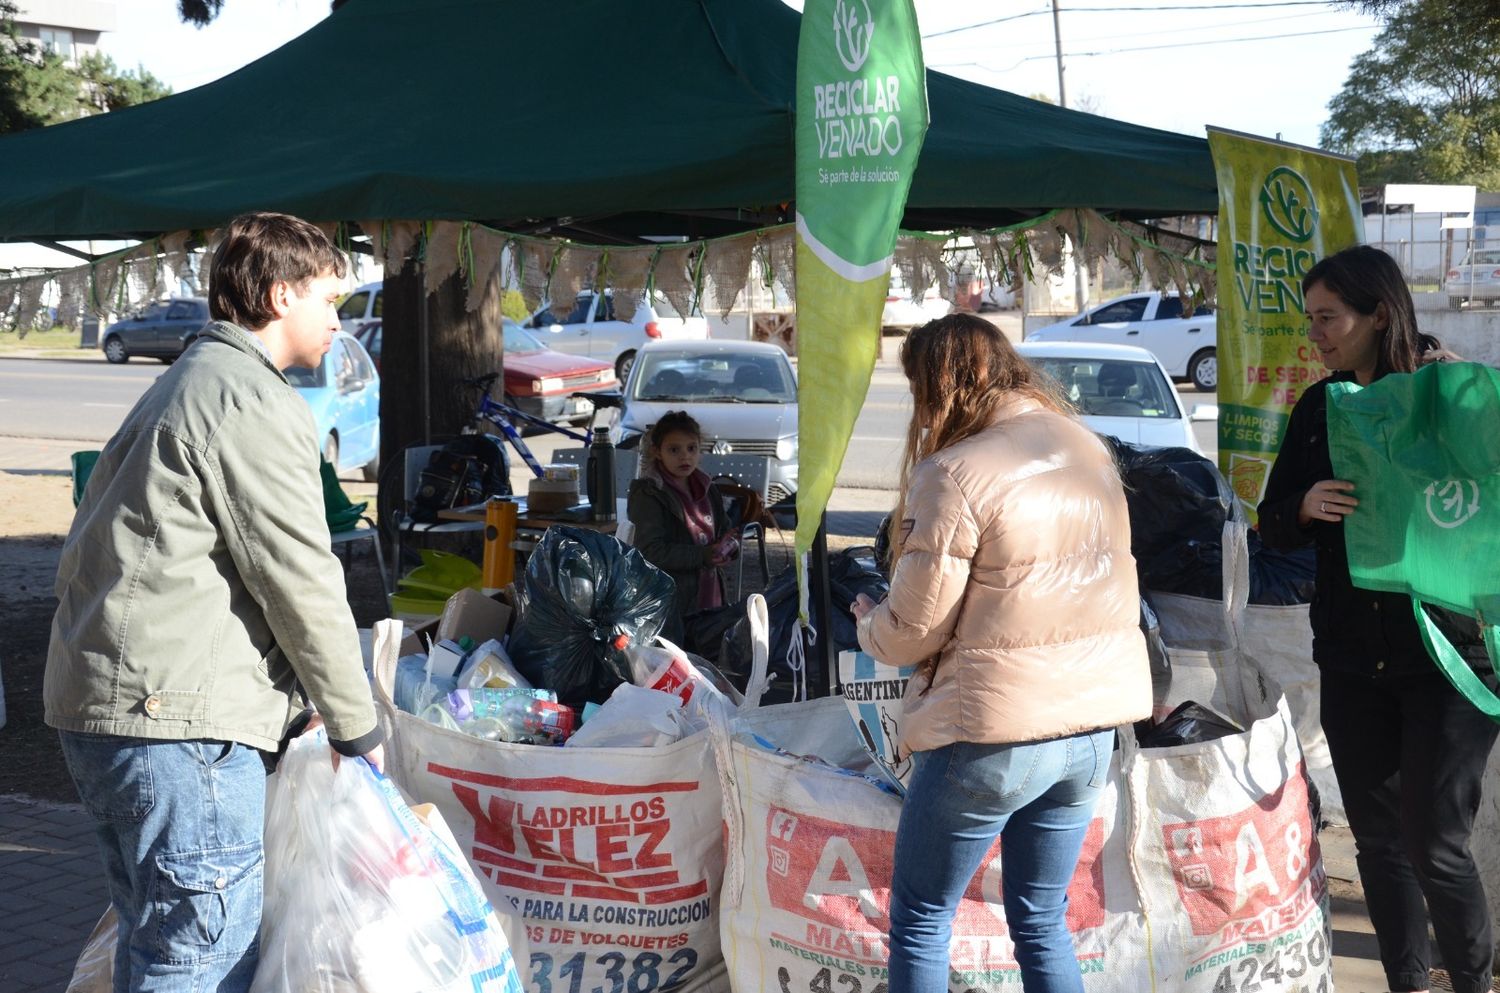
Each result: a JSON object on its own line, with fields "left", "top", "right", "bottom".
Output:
{"left": 0, "top": 0, "right": 1217, "bottom": 243}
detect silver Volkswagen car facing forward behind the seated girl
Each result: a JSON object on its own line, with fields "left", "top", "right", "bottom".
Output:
{"left": 615, "top": 341, "right": 797, "bottom": 504}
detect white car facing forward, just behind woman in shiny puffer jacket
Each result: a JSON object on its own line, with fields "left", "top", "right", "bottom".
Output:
{"left": 1016, "top": 342, "right": 1218, "bottom": 455}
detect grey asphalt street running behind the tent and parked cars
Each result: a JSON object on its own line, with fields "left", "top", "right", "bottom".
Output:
{"left": 0, "top": 358, "right": 1218, "bottom": 489}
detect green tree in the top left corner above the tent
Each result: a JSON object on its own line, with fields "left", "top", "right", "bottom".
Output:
{"left": 0, "top": 0, "right": 171, "bottom": 135}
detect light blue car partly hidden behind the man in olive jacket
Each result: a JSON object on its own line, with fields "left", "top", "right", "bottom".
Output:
{"left": 287, "top": 332, "right": 380, "bottom": 482}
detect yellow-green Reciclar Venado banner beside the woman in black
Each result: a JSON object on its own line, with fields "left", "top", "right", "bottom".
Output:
{"left": 1209, "top": 128, "right": 1364, "bottom": 522}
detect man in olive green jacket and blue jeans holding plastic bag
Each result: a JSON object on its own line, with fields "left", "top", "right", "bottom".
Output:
{"left": 44, "top": 213, "right": 383, "bottom": 993}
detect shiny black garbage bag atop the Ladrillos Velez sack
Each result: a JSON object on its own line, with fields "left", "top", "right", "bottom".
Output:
{"left": 510, "top": 525, "right": 675, "bottom": 707}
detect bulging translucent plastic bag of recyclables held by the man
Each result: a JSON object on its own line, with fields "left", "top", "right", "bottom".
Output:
{"left": 251, "top": 731, "right": 522, "bottom": 993}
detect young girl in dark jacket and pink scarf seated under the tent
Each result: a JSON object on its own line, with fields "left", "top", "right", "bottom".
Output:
{"left": 626, "top": 411, "right": 740, "bottom": 645}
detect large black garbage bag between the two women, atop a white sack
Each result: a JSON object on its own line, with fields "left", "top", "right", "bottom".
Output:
{"left": 1106, "top": 437, "right": 1317, "bottom": 606}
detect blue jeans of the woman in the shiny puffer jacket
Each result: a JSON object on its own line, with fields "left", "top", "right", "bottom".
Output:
{"left": 890, "top": 731, "right": 1115, "bottom": 993}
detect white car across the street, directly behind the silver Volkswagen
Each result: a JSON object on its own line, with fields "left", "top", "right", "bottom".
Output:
{"left": 527, "top": 290, "right": 708, "bottom": 383}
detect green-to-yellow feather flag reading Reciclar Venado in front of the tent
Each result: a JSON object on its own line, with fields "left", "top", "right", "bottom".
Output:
{"left": 797, "top": 0, "right": 927, "bottom": 618}
